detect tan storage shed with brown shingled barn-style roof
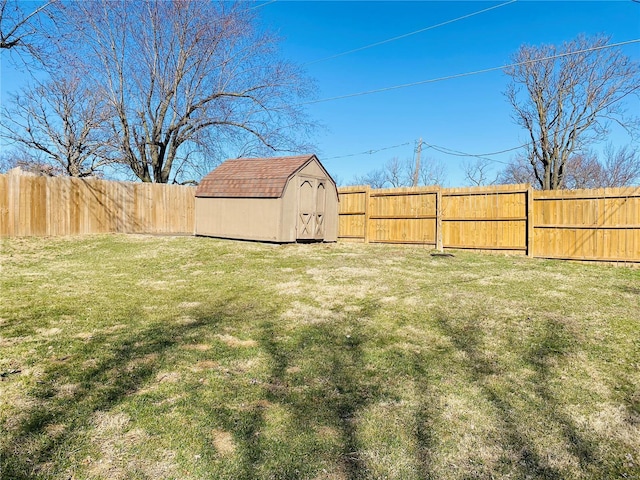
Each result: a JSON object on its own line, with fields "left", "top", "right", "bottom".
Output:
{"left": 195, "top": 155, "right": 338, "bottom": 243}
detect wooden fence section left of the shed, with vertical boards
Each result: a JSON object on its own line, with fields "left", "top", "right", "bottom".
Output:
{"left": 0, "top": 173, "right": 195, "bottom": 237}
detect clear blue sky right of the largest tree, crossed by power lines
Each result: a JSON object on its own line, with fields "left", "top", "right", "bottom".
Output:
{"left": 256, "top": 0, "right": 640, "bottom": 186}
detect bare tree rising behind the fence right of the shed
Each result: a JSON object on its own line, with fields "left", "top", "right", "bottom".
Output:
{"left": 505, "top": 36, "right": 640, "bottom": 190}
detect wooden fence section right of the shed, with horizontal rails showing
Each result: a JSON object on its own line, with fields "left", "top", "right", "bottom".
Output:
{"left": 339, "top": 184, "right": 640, "bottom": 262}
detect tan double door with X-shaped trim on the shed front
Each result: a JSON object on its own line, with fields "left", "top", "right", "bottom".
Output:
{"left": 297, "top": 177, "right": 326, "bottom": 240}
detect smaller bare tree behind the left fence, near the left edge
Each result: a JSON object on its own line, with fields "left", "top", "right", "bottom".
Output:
{"left": 0, "top": 75, "right": 113, "bottom": 177}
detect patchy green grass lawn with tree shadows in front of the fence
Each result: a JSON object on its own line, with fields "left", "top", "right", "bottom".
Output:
{"left": 0, "top": 236, "right": 640, "bottom": 480}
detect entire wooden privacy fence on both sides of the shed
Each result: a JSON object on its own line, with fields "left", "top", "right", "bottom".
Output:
{"left": 0, "top": 173, "right": 640, "bottom": 263}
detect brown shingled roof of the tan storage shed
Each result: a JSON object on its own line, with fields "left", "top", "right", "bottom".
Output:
{"left": 196, "top": 155, "right": 318, "bottom": 198}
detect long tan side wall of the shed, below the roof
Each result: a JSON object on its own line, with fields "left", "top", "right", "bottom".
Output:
{"left": 195, "top": 198, "right": 282, "bottom": 242}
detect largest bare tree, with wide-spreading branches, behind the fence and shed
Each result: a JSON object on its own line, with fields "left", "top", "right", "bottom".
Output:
{"left": 55, "top": 0, "right": 310, "bottom": 183}
